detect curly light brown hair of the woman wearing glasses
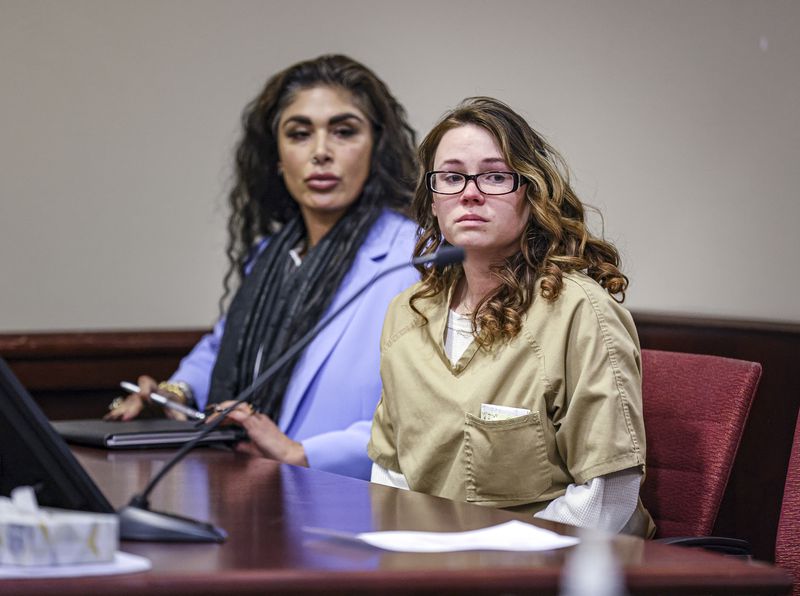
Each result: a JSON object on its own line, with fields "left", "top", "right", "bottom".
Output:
{"left": 409, "top": 97, "right": 628, "bottom": 347}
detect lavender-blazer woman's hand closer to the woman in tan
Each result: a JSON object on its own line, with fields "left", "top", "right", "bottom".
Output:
{"left": 212, "top": 401, "right": 308, "bottom": 467}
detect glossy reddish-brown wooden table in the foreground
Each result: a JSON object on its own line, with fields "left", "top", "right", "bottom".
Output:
{"left": 0, "top": 448, "right": 791, "bottom": 596}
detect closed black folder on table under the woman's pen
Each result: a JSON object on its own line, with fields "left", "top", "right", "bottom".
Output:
{"left": 50, "top": 418, "right": 245, "bottom": 449}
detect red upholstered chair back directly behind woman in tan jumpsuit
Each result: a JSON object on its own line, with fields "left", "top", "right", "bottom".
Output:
{"left": 641, "top": 350, "right": 761, "bottom": 538}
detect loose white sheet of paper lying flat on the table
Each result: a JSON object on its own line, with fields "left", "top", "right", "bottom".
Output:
{"left": 304, "top": 520, "right": 579, "bottom": 553}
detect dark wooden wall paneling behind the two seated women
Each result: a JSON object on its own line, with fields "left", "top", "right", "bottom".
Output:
{"left": 0, "top": 313, "right": 800, "bottom": 561}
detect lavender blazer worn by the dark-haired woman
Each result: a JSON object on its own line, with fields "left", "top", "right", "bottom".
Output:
{"left": 170, "top": 210, "right": 419, "bottom": 479}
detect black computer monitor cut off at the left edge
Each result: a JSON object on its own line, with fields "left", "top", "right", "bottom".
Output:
{"left": 0, "top": 358, "right": 114, "bottom": 513}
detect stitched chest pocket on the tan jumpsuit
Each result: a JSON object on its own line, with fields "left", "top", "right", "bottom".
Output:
{"left": 464, "top": 412, "right": 552, "bottom": 507}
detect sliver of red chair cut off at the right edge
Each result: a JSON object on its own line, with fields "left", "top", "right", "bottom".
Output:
{"left": 775, "top": 416, "right": 800, "bottom": 596}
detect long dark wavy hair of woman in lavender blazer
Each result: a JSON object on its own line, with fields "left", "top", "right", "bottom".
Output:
{"left": 220, "top": 55, "right": 417, "bottom": 310}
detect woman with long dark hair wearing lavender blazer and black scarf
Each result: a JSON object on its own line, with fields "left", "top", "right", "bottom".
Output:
{"left": 107, "top": 56, "right": 418, "bottom": 478}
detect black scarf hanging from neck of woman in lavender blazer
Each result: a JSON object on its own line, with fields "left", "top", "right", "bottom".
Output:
{"left": 208, "top": 205, "right": 381, "bottom": 422}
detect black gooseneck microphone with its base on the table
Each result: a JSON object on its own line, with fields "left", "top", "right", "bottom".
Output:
{"left": 117, "top": 245, "right": 464, "bottom": 542}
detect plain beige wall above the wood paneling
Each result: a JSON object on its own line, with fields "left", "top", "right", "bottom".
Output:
{"left": 0, "top": 0, "right": 800, "bottom": 331}
